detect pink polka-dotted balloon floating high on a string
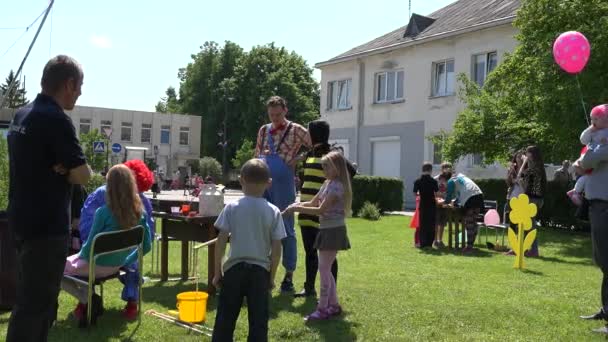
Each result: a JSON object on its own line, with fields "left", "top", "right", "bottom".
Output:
{"left": 553, "top": 31, "right": 591, "bottom": 74}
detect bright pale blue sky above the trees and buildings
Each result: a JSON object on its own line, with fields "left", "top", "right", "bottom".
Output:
{"left": 0, "top": 0, "right": 455, "bottom": 111}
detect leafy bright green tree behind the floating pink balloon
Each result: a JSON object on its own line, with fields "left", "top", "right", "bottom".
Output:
{"left": 444, "top": 0, "right": 608, "bottom": 162}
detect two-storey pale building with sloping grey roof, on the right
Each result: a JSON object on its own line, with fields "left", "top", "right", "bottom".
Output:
{"left": 316, "top": 0, "right": 520, "bottom": 206}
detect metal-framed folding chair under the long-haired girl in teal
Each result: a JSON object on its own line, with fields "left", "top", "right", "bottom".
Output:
{"left": 63, "top": 226, "right": 145, "bottom": 325}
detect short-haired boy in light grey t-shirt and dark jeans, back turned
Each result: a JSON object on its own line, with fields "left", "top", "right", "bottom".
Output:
{"left": 212, "top": 159, "right": 286, "bottom": 341}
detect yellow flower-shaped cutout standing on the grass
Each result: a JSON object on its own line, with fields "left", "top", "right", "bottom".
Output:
{"left": 509, "top": 194, "right": 537, "bottom": 269}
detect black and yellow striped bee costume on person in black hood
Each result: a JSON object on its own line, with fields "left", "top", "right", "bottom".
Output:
{"left": 298, "top": 157, "right": 325, "bottom": 229}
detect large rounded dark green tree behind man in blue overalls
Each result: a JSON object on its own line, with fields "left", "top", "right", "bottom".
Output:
{"left": 159, "top": 41, "right": 319, "bottom": 165}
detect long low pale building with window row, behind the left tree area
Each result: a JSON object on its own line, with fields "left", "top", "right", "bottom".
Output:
{"left": 67, "top": 106, "right": 201, "bottom": 175}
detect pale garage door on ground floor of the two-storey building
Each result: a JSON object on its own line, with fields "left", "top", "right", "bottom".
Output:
{"left": 372, "top": 138, "right": 401, "bottom": 178}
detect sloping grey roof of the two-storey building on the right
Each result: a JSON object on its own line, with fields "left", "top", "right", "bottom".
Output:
{"left": 317, "top": 0, "right": 520, "bottom": 66}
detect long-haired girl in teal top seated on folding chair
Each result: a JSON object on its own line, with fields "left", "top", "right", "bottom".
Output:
{"left": 61, "top": 164, "right": 152, "bottom": 327}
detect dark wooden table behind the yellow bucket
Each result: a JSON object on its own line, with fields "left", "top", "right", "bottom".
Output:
{"left": 153, "top": 212, "right": 217, "bottom": 294}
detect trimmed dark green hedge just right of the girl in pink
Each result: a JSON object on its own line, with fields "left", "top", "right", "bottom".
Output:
{"left": 353, "top": 176, "right": 403, "bottom": 213}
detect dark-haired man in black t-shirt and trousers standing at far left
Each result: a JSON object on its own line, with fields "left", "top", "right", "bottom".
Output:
{"left": 7, "top": 56, "right": 91, "bottom": 342}
